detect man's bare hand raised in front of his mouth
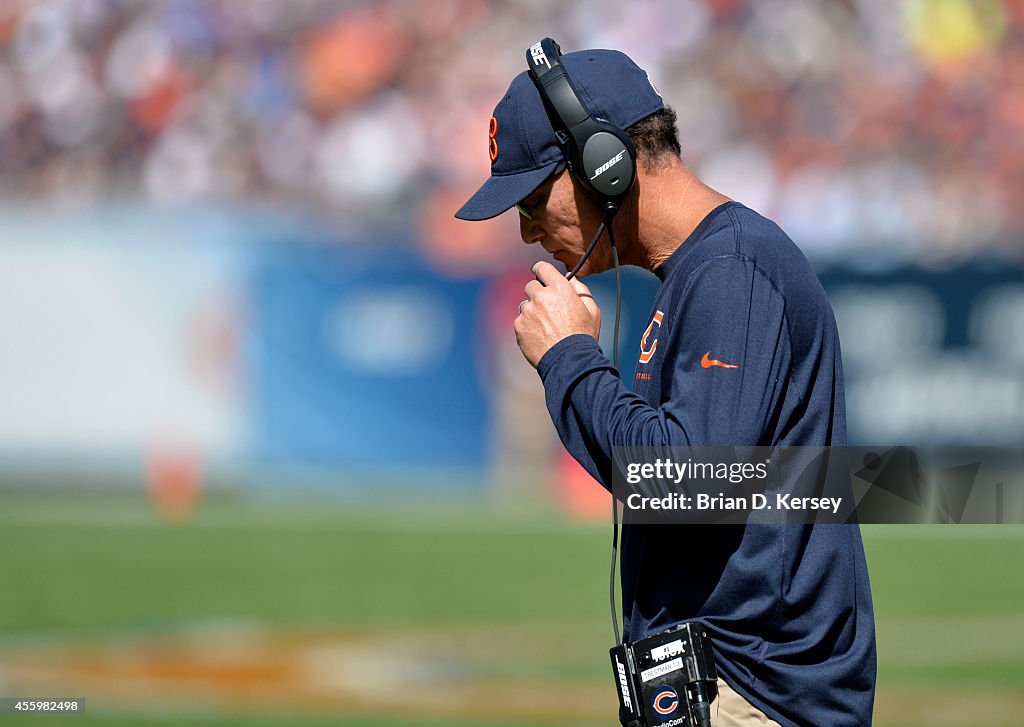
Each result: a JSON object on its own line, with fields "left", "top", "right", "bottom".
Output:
{"left": 515, "top": 261, "right": 601, "bottom": 368}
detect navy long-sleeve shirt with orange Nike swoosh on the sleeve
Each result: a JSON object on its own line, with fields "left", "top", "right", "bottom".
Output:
{"left": 538, "top": 202, "right": 876, "bottom": 727}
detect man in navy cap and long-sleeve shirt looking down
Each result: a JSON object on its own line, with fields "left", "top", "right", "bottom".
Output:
{"left": 457, "top": 50, "right": 876, "bottom": 727}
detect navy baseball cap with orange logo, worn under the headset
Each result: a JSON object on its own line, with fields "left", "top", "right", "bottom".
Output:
{"left": 455, "top": 50, "right": 665, "bottom": 220}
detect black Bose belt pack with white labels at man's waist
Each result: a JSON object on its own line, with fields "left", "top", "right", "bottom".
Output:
{"left": 608, "top": 622, "right": 718, "bottom": 727}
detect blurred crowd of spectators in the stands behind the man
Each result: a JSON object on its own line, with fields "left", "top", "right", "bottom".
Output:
{"left": 0, "top": 0, "right": 1024, "bottom": 273}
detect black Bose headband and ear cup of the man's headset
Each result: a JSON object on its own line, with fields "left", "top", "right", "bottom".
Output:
{"left": 526, "top": 38, "right": 636, "bottom": 210}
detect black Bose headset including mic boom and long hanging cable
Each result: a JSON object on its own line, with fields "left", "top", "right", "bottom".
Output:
{"left": 526, "top": 38, "right": 637, "bottom": 646}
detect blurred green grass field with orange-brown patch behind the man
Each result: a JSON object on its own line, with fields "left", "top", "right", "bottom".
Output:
{"left": 0, "top": 489, "right": 1024, "bottom": 727}
